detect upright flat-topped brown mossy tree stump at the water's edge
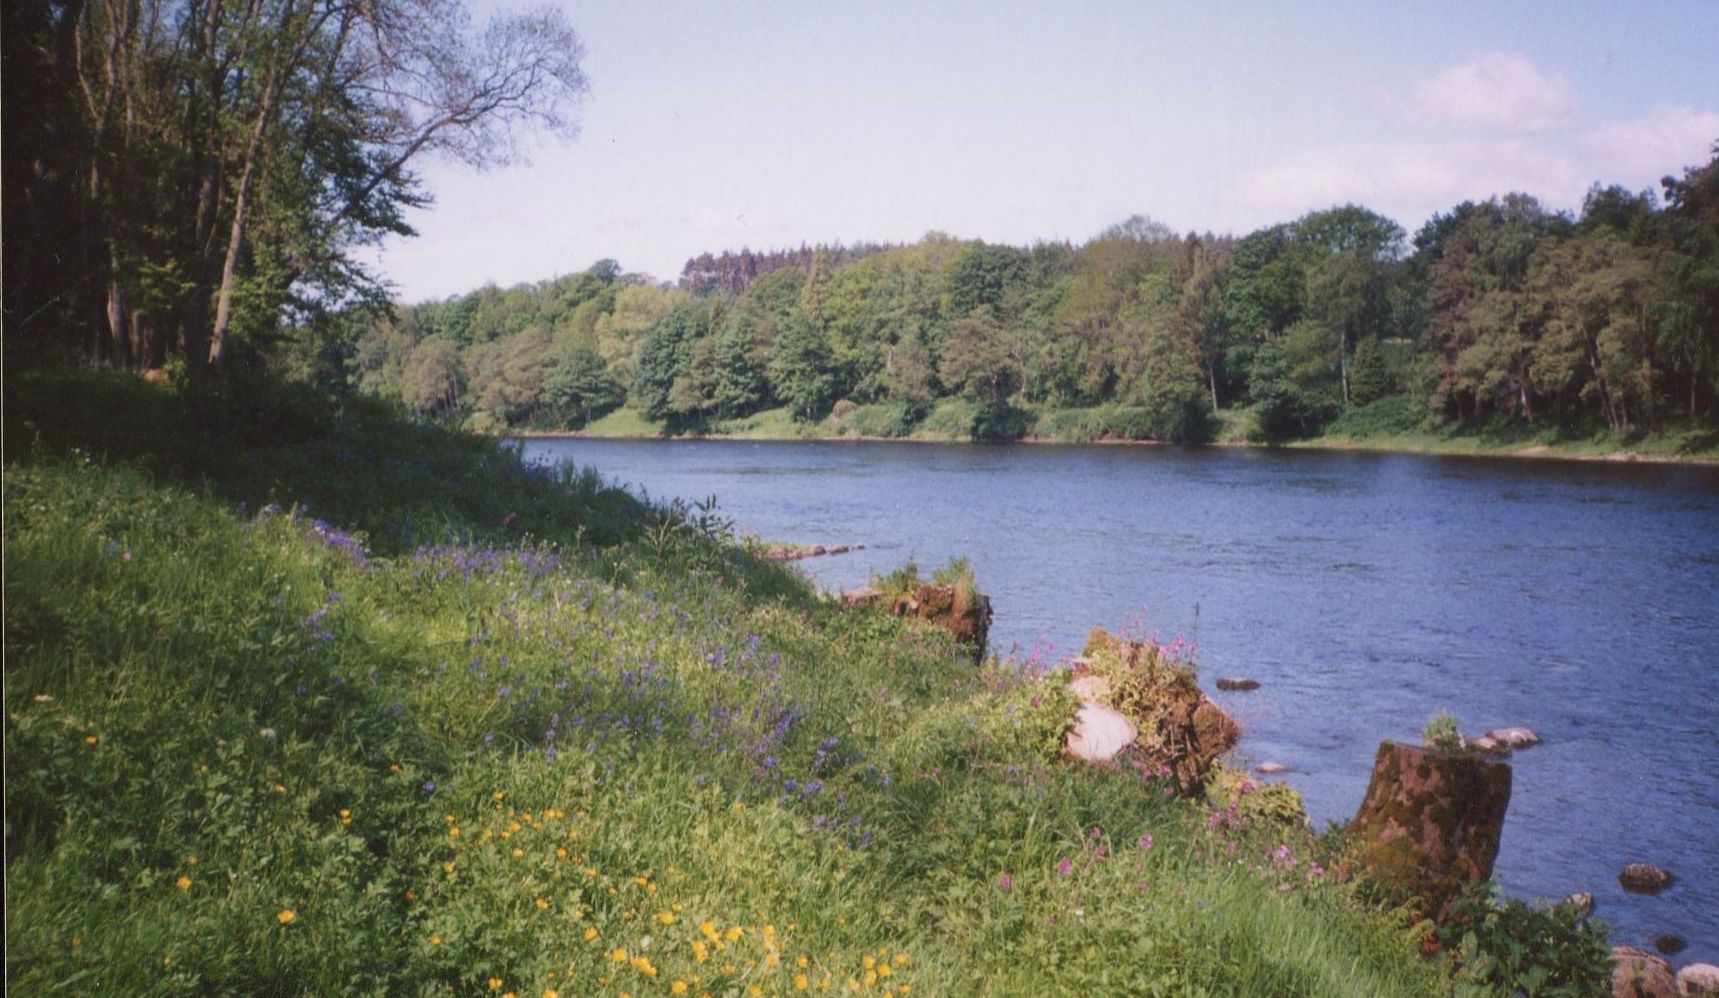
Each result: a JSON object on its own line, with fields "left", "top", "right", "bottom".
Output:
{"left": 1349, "top": 742, "right": 1511, "bottom": 919}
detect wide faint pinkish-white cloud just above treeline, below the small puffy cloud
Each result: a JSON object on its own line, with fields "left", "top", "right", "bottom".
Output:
{"left": 1233, "top": 139, "right": 1590, "bottom": 228}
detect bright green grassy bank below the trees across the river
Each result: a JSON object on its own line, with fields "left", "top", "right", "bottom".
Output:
{"left": 550, "top": 399, "right": 1719, "bottom": 464}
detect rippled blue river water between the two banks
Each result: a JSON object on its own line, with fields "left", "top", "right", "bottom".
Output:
{"left": 524, "top": 440, "right": 1719, "bottom": 965}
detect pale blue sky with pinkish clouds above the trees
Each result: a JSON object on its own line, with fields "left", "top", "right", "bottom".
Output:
{"left": 375, "top": 0, "right": 1719, "bottom": 301}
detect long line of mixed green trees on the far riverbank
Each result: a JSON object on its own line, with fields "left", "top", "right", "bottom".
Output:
{"left": 296, "top": 148, "right": 1719, "bottom": 440}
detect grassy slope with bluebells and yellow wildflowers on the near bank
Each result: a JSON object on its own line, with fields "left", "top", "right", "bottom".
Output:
{"left": 5, "top": 369, "right": 1447, "bottom": 996}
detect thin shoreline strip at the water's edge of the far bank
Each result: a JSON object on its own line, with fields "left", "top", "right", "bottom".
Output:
{"left": 495, "top": 429, "right": 1719, "bottom": 467}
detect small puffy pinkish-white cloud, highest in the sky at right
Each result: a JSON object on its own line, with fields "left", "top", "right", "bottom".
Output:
{"left": 1415, "top": 52, "right": 1573, "bottom": 132}
